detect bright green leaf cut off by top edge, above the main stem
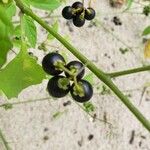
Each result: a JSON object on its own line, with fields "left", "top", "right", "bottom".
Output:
{"left": 29, "top": 0, "right": 61, "bottom": 11}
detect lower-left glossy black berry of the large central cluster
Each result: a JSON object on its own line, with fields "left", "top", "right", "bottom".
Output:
{"left": 47, "top": 76, "right": 70, "bottom": 98}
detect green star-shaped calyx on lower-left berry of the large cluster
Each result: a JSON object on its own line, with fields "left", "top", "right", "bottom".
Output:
{"left": 58, "top": 78, "right": 70, "bottom": 90}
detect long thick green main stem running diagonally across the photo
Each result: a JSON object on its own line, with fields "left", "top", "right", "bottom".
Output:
{"left": 15, "top": 0, "right": 150, "bottom": 131}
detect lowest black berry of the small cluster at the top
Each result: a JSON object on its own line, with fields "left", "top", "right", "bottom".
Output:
{"left": 73, "top": 15, "right": 85, "bottom": 27}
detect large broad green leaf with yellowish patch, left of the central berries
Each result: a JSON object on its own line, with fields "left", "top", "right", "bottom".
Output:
{"left": 0, "top": 47, "right": 46, "bottom": 99}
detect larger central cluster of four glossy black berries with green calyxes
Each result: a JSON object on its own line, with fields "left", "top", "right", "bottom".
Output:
{"left": 42, "top": 52, "right": 93, "bottom": 102}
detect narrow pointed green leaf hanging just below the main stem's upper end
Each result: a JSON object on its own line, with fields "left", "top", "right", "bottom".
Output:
{"left": 23, "top": 15, "right": 37, "bottom": 47}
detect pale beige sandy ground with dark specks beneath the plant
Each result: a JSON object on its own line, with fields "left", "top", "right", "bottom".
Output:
{"left": 0, "top": 0, "right": 150, "bottom": 150}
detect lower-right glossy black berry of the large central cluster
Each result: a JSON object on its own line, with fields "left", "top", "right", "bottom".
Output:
{"left": 70, "top": 80, "right": 93, "bottom": 103}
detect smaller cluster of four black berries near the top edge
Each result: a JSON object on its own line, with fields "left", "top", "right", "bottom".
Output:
{"left": 62, "top": 2, "right": 95, "bottom": 27}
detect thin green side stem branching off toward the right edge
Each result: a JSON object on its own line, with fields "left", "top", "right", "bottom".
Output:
{"left": 107, "top": 65, "right": 150, "bottom": 78}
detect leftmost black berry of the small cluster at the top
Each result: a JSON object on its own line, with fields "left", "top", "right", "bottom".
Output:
{"left": 62, "top": 6, "right": 74, "bottom": 19}
